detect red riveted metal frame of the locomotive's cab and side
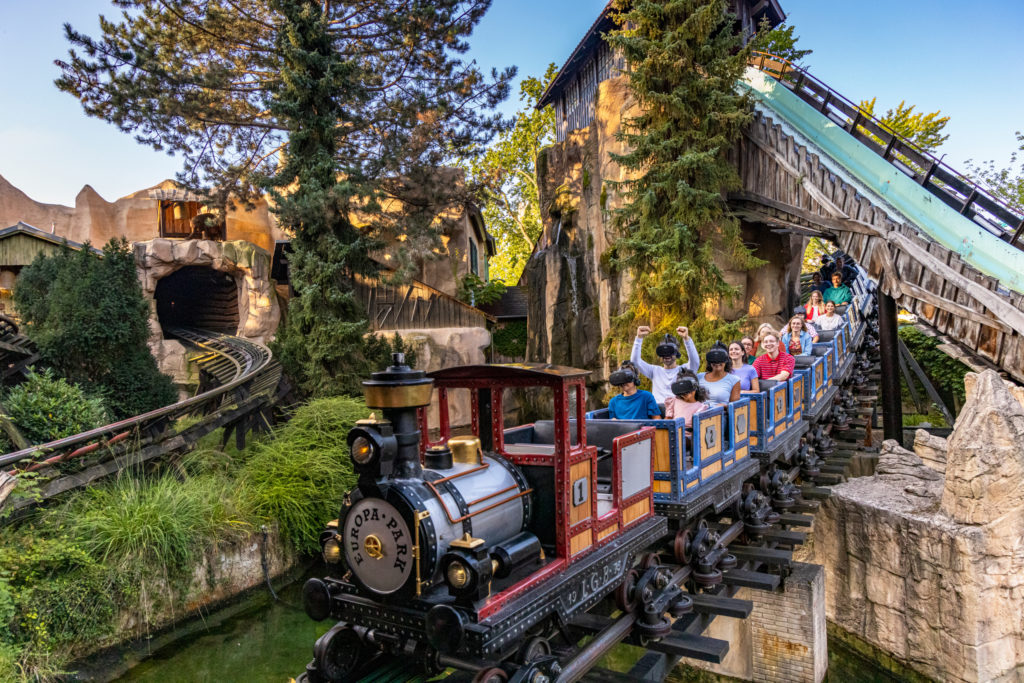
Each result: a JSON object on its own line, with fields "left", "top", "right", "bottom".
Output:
{"left": 419, "top": 365, "right": 654, "bottom": 621}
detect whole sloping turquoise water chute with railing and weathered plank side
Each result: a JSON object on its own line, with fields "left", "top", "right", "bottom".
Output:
{"left": 729, "top": 53, "right": 1024, "bottom": 381}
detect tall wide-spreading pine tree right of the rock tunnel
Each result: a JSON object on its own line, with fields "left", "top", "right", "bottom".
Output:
{"left": 57, "top": 0, "right": 514, "bottom": 393}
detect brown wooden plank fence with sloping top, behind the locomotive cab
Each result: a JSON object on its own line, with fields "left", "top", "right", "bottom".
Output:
{"left": 355, "top": 280, "right": 495, "bottom": 331}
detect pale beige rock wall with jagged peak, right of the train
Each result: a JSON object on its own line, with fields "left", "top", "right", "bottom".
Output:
{"left": 812, "top": 371, "right": 1024, "bottom": 683}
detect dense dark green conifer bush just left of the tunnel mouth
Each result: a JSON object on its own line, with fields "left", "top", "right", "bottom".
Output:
{"left": 14, "top": 238, "right": 177, "bottom": 419}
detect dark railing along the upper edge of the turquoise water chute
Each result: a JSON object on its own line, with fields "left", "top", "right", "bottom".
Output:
{"left": 751, "top": 52, "right": 1024, "bottom": 249}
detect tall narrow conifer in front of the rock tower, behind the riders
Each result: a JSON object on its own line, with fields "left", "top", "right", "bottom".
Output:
{"left": 608, "top": 0, "right": 761, "bottom": 336}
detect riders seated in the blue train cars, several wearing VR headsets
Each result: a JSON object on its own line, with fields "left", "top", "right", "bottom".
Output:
{"left": 608, "top": 256, "right": 857, "bottom": 427}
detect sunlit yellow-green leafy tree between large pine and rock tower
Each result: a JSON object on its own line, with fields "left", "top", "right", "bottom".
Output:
{"left": 467, "top": 63, "right": 557, "bottom": 283}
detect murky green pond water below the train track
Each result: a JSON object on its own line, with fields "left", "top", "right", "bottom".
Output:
{"left": 118, "top": 581, "right": 904, "bottom": 683}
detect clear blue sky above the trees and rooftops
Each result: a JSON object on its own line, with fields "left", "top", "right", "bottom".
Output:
{"left": 0, "top": 0, "right": 1024, "bottom": 205}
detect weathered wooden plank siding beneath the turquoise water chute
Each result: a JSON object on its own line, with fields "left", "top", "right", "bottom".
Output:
{"left": 730, "top": 114, "right": 1024, "bottom": 381}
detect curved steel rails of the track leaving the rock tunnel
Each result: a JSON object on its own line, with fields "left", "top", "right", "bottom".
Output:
{"left": 0, "top": 328, "right": 275, "bottom": 468}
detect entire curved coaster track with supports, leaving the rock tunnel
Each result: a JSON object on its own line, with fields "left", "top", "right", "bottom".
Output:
{"left": 0, "top": 328, "right": 282, "bottom": 510}
